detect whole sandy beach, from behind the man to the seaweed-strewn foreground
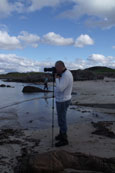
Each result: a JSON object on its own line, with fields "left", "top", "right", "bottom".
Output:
{"left": 0, "top": 80, "right": 115, "bottom": 173}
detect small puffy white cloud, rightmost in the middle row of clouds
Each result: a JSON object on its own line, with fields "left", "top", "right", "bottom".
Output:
{"left": 75, "top": 34, "right": 94, "bottom": 47}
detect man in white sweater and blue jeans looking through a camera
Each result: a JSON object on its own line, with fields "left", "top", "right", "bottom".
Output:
{"left": 55, "top": 61, "right": 73, "bottom": 147}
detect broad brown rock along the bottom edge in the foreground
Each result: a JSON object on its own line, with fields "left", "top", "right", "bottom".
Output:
{"left": 17, "top": 150, "right": 115, "bottom": 173}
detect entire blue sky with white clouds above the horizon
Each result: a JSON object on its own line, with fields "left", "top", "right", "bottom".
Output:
{"left": 0, "top": 0, "right": 115, "bottom": 73}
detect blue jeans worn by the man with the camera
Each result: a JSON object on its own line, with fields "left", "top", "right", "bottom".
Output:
{"left": 56, "top": 100, "right": 71, "bottom": 134}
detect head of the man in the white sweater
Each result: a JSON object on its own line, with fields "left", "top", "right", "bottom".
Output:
{"left": 55, "top": 61, "right": 65, "bottom": 74}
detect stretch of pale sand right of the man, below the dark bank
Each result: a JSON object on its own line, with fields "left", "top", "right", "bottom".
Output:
{"left": 72, "top": 80, "right": 115, "bottom": 114}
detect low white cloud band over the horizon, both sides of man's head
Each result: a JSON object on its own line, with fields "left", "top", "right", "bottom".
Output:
{"left": 0, "top": 54, "right": 115, "bottom": 73}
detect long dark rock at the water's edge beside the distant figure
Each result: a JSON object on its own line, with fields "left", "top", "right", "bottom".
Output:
{"left": 22, "top": 86, "right": 51, "bottom": 93}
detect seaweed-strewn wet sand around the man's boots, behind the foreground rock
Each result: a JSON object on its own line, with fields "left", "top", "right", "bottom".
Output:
{"left": 0, "top": 122, "right": 115, "bottom": 173}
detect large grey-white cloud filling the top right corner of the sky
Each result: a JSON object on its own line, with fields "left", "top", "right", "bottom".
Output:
{"left": 62, "top": 0, "right": 115, "bottom": 28}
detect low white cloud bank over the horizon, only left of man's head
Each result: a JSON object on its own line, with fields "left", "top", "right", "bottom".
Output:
{"left": 0, "top": 54, "right": 53, "bottom": 73}
